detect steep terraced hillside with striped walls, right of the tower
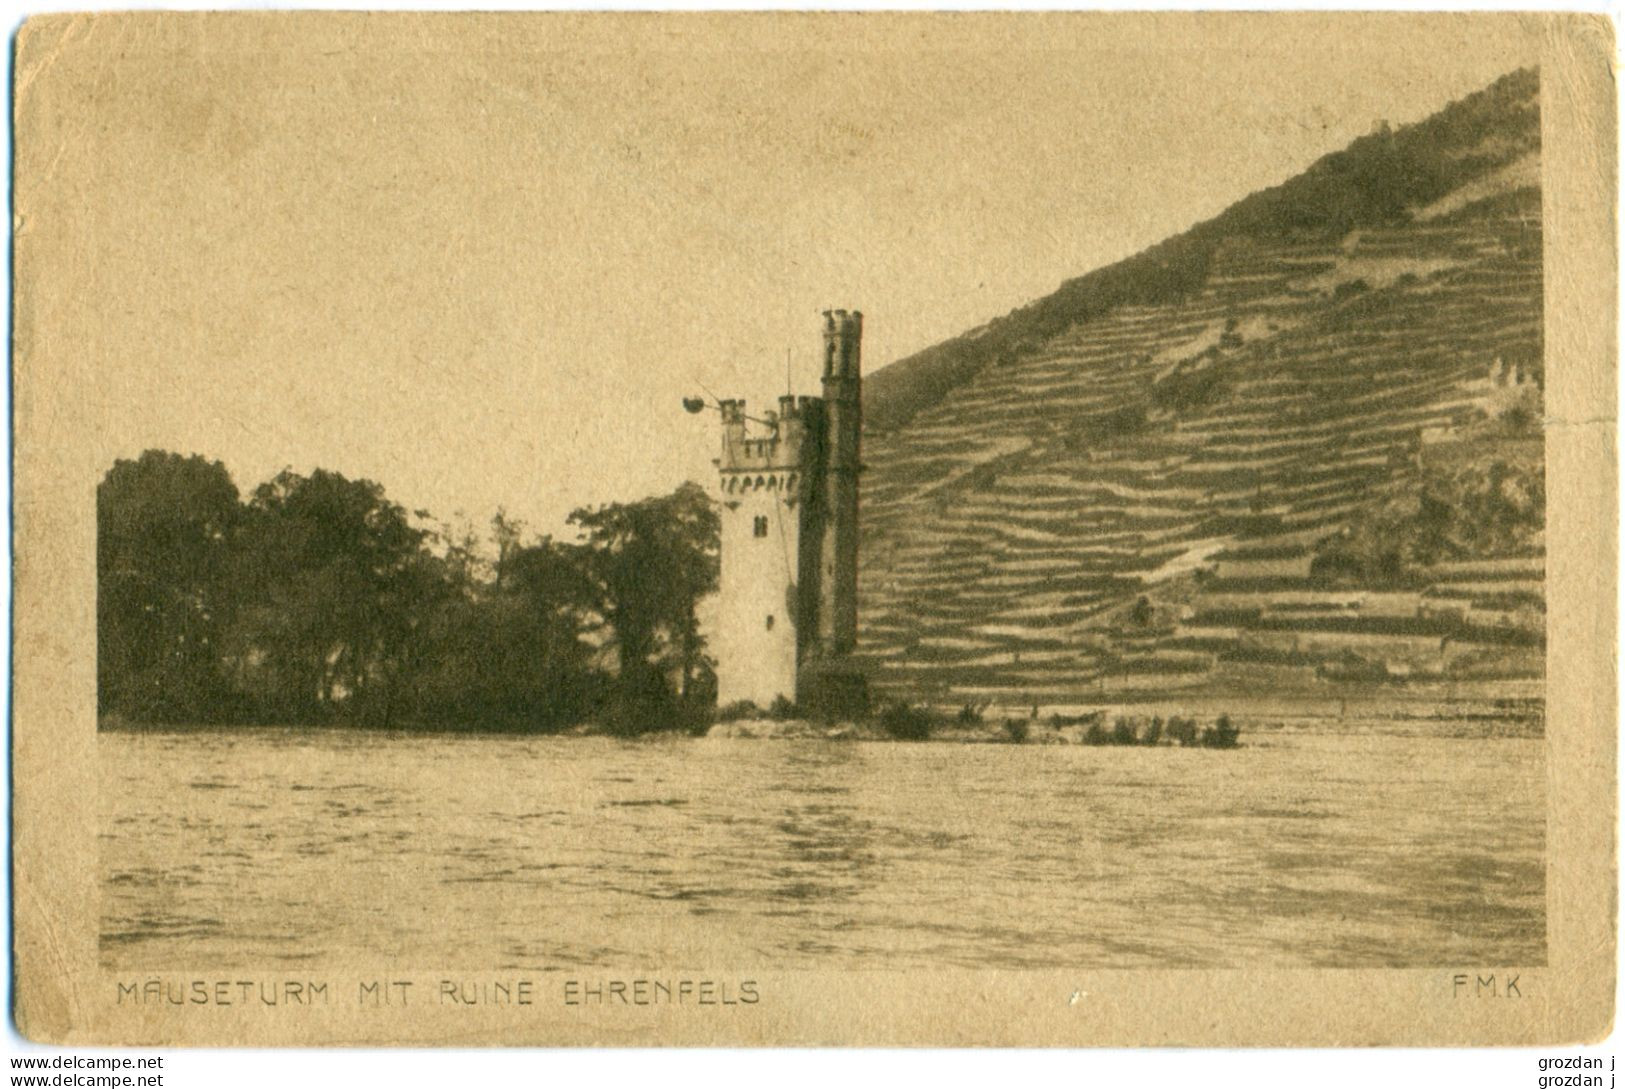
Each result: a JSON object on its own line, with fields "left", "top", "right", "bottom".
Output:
{"left": 860, "top": 72, "right": 1545, "bottom": 704}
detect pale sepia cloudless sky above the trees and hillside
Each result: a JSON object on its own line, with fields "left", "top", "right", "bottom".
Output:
{"left": 28, "top": 15, "right": 1539, "bottom": 533}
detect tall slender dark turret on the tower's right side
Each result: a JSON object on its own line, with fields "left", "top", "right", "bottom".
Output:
{"left": 796, "top": 310, "right": 868, "bottom": 715}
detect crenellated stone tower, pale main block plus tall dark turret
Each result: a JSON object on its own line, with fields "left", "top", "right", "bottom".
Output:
{"left": 712, "top": 310, "right": 866, "bottom": 714}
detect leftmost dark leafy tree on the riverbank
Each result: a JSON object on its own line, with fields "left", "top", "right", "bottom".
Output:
{"left": 96, "top": 450, "right": 242, "bottom": 722}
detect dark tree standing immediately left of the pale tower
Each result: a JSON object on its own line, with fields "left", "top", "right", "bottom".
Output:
{"left": 570, "top": 481, "right": 722, "bottom": 724}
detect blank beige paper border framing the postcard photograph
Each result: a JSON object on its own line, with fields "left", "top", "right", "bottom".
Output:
{"left": 13, "top": 15, "right": 1617, "bottom": 1045}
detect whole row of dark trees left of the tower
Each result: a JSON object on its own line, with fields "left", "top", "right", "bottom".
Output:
{"left": 96, "top": 450, "right": 718, "bottom": 733}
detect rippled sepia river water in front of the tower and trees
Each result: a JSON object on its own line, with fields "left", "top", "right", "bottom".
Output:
{"left": 99, "top": 730, "right": 1545, "bottom": 970}
